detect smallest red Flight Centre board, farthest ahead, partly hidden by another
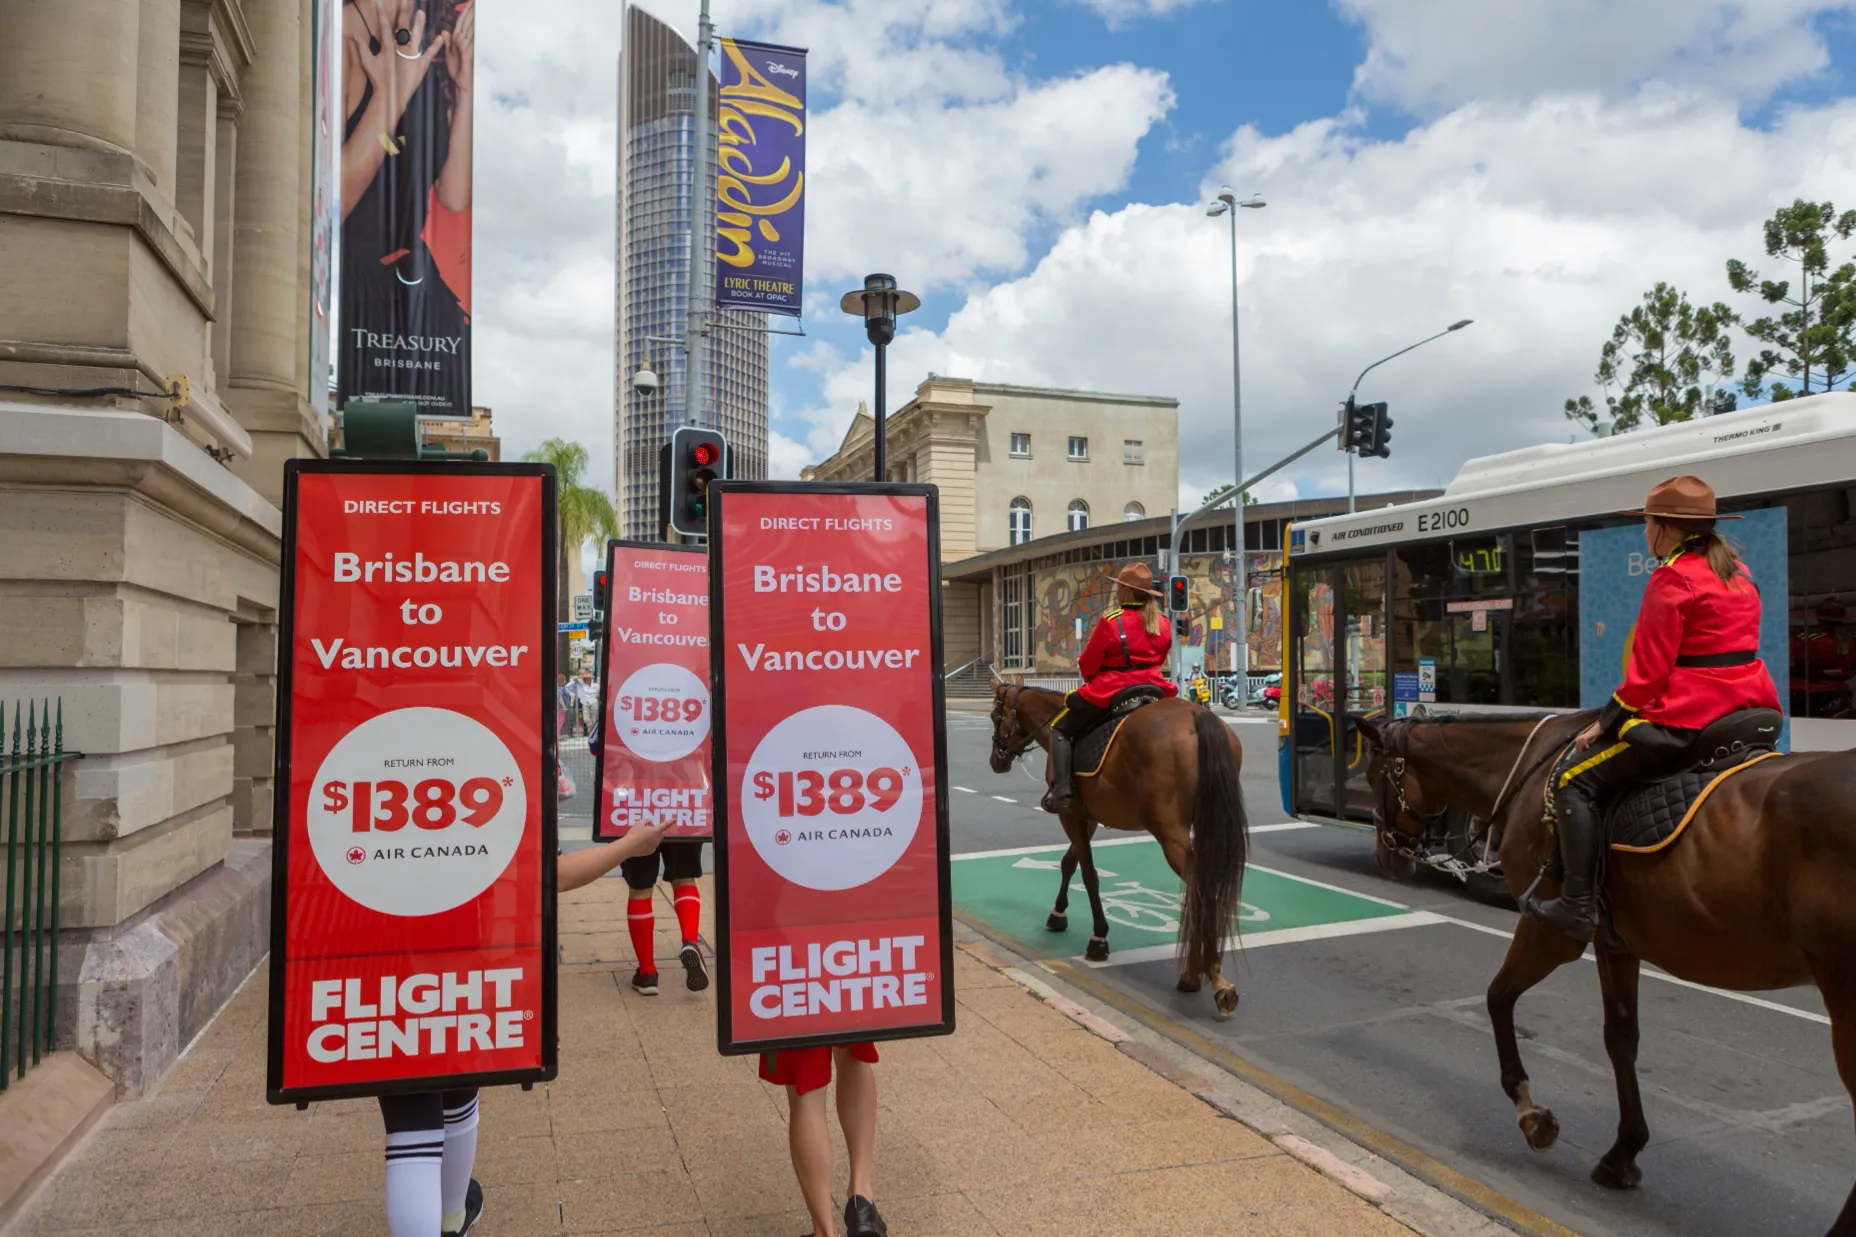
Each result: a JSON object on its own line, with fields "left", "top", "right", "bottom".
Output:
{"left": 592, "top": 540, "right": 715, "bottom": 840}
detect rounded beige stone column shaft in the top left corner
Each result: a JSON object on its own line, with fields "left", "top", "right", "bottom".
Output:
{"left": 0, "top": 0, "right": 141, "bottom": 154}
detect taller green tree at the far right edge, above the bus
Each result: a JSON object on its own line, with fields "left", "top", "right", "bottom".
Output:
{"left": 1728, "top": 199, "right": 1856, "bottom": 399}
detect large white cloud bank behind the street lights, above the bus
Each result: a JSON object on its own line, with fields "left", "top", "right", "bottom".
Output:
{"left": 786, "top": 89, "right": 1856, "bottom": 496}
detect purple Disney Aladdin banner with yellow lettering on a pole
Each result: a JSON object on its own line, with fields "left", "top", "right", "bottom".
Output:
{"left": 715, "top": 39, "right": 806, "bottom": 318}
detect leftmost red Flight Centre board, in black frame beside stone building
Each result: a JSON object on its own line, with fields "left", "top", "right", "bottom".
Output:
{"left": 265, "top": 461, "right": 555, "bottom": 1103}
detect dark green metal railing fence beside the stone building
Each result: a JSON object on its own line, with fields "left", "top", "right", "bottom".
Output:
{"left": 0, "top": 700, "right": 78, "bottom": 1090}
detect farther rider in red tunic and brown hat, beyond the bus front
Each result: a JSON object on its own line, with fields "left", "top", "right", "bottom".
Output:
{"left": 1043, "top": 563, "right": 1179, "bottom": 815}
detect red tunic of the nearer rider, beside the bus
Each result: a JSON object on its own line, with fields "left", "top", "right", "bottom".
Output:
{"left": 1607, "top": 546, "right": 1780, "bottom": 730}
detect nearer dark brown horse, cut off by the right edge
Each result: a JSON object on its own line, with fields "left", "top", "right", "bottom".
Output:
{"left": 1359, "top": 713, "right": 1856, "bottom": 1237}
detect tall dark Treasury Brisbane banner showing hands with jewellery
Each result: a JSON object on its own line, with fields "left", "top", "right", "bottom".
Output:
{"left": 336, "top": 0, "right": 477, "bottom": 418}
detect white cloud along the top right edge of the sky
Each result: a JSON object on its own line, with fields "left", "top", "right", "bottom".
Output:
{"left": 1340, "top": 0, "right": 1852, "bottom": 115}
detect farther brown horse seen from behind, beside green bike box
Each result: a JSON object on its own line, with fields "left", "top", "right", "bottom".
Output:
{"left": 993, "top": 684, "right": 1249, "bottom": 1018}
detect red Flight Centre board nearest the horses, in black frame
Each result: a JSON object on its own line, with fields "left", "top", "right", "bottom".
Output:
{"left": 709, "top": 481, "right": 954, "bottom": 1053}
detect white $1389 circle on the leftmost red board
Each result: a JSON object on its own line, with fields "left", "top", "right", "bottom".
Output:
{"left": 306, "top": 708, "right": 529, "bottom": 916}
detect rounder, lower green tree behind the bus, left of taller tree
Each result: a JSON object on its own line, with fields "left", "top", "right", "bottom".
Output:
{"left": 1566, "top": 282, "right": 1739, "bottom": 435}
